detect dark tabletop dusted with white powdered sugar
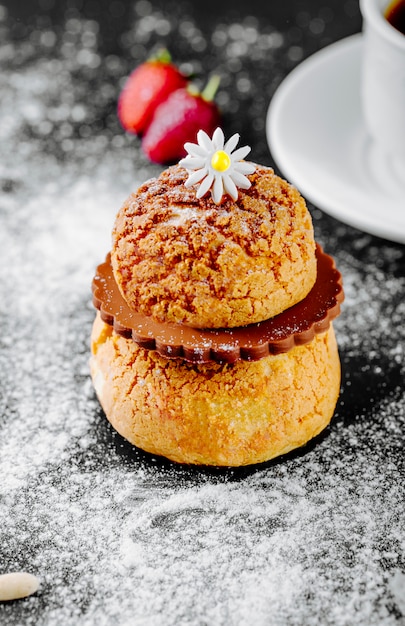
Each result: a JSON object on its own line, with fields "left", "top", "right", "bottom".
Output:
{"left": 0, "top": 0, "right": 405, "bottom": 626}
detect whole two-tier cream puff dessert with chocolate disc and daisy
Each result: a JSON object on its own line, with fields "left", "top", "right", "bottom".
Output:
{"left": 90, "top": 128, "right": 343, "bottom": 466}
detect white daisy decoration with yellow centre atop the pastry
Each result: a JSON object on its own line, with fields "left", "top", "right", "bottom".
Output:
{"left": 179, "top": 128, "right": 256, "bottom": 204}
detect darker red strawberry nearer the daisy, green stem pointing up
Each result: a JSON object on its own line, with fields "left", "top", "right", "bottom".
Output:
{"left": 142, "top": 76, "right": 221, "bottom": 164}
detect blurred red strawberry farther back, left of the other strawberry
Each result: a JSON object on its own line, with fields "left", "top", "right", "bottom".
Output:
{"left": 118, "top": 50, "right": 188, "bottom": 135}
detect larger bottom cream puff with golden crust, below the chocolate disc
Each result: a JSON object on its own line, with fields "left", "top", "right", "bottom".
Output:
{"left": 91, "top": 313, "right": 340, "bottom": 466}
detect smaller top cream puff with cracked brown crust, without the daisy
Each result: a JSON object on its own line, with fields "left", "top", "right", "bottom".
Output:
{"left": 111, "top": 165, "right": 316, "bottom": 328}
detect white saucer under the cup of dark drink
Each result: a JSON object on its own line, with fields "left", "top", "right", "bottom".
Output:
{"left": 267, "top": 35, "right": 405, "bottom": 243}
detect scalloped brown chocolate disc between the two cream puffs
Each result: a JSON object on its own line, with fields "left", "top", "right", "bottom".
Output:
{"left": 92, "top": 244, "right": 344, "bottom": 363}
